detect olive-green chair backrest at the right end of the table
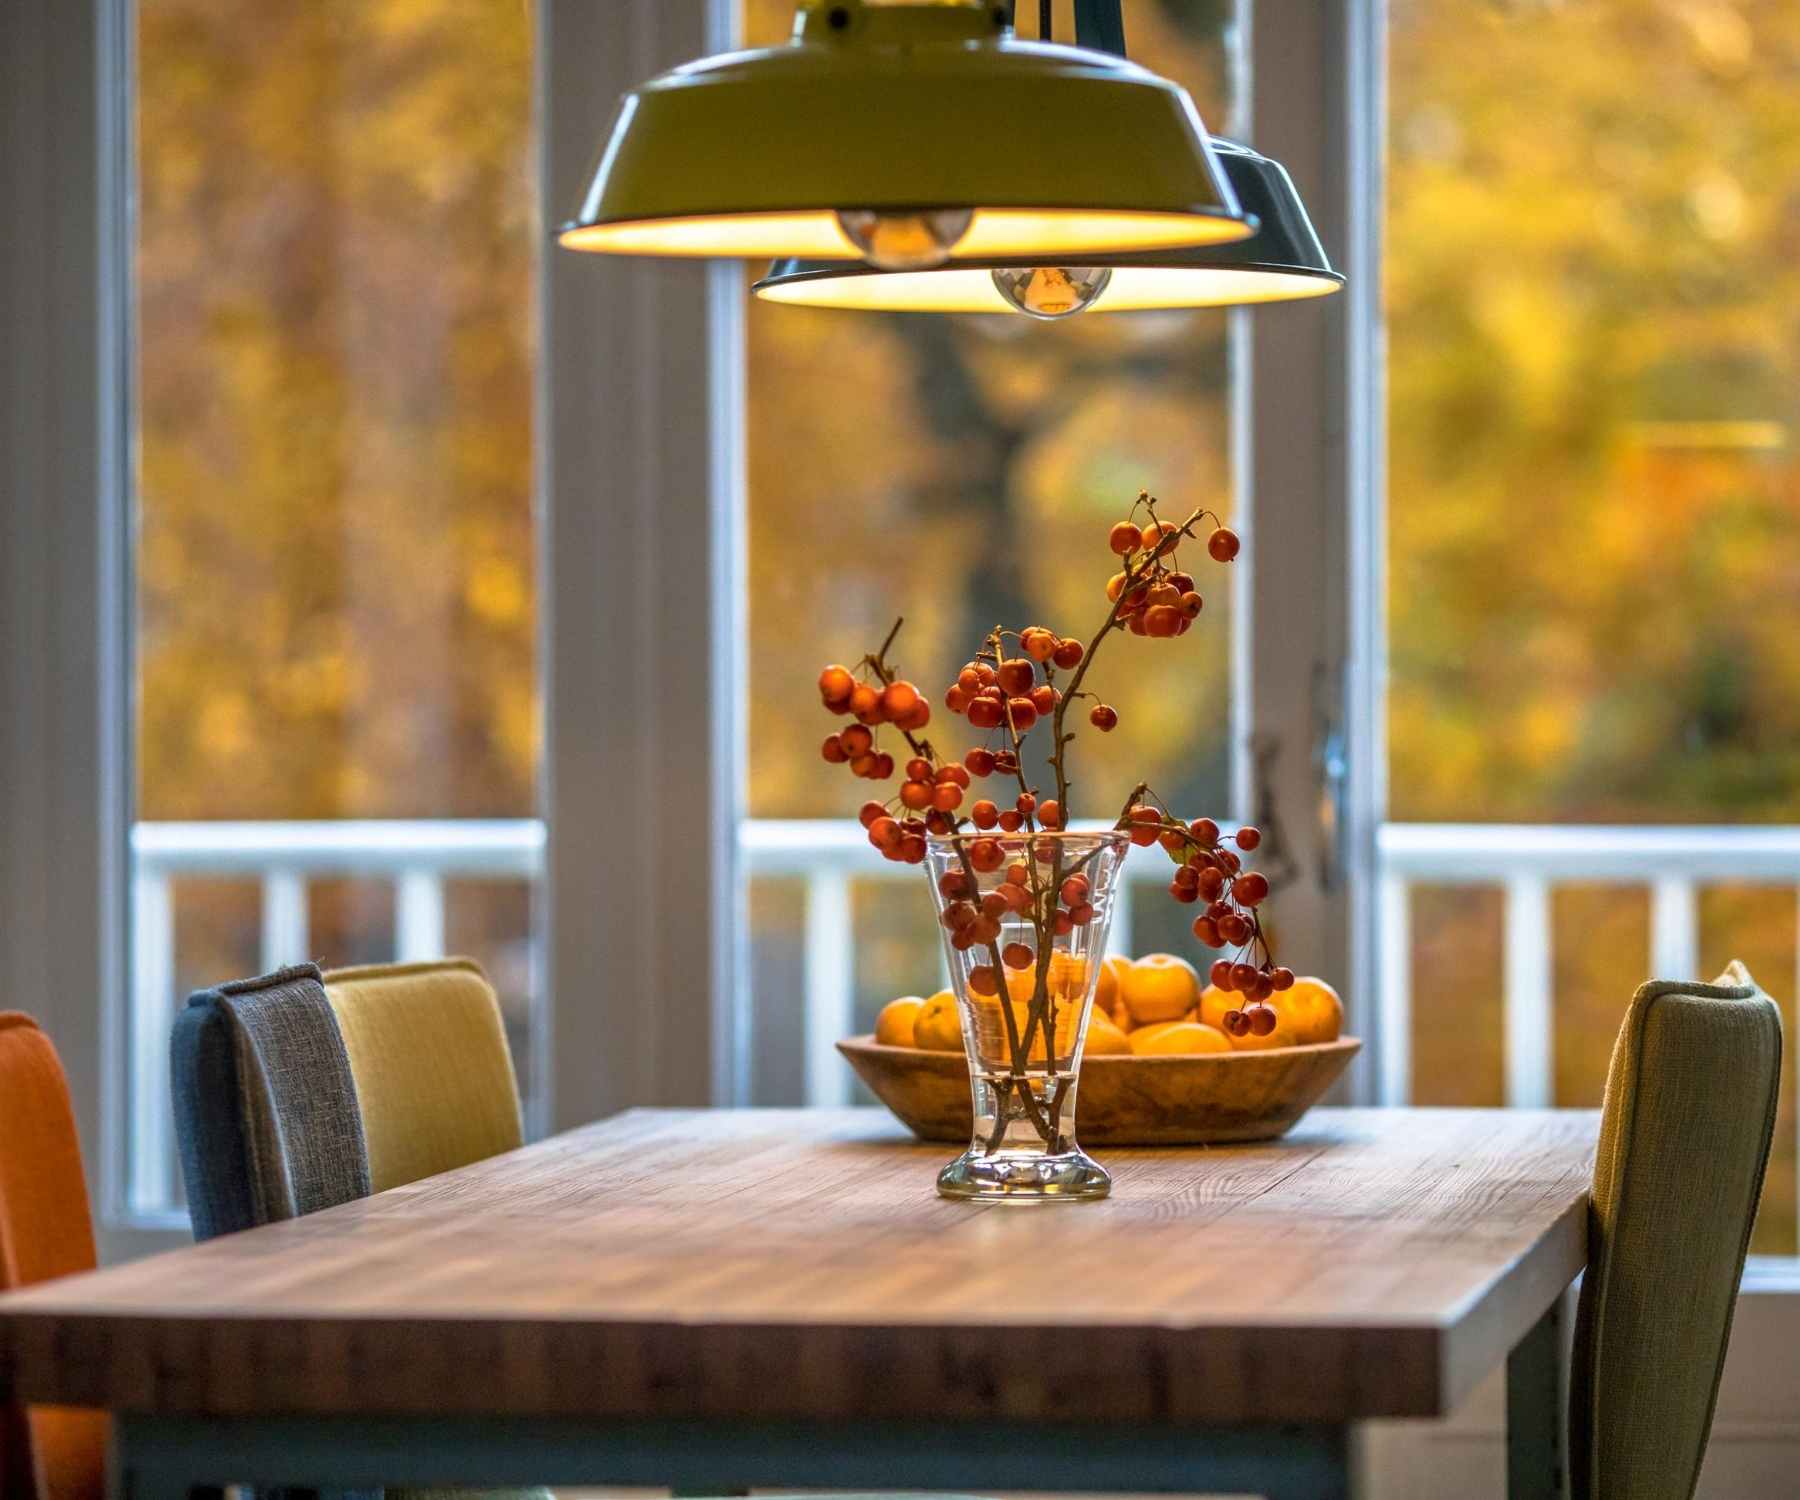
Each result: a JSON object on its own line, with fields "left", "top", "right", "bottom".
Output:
{"left": 1570, "top": 963, "right": 1782, "bottom": 1500}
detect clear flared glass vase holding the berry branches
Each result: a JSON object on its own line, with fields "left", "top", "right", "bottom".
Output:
{"left": 925, "top": 832, "right": 1130, "bottom": 1203}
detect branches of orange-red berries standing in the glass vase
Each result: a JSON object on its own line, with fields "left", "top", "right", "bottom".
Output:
{"left": 819, "top": 490, "right": 1294, "bottom": 1149}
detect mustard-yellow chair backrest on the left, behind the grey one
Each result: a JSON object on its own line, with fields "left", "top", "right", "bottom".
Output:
{"left": 324, "top": 958, "right": 524, "bottom": 1192}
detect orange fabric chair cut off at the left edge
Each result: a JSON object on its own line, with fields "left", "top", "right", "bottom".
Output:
{"left": 0, "top": 1010, "right": 106, "bottom": 1500}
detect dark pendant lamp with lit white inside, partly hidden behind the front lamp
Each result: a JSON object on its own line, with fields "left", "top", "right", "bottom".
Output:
{"left": 754, "top": 0, "right": 1345, "bottom": 319}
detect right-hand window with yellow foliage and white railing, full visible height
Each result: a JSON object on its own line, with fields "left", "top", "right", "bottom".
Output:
{"left": 1382, "top": 0, "right": 1800, "bottom": 1255}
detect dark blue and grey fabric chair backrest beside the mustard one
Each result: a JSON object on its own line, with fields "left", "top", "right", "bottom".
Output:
{"left": 171, "top": 963, "right": 369, "bottom": 1239}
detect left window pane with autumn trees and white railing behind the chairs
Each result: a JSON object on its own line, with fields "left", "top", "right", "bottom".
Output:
{"left": 133, "top": 0, "right": 540, "bottom": 1208}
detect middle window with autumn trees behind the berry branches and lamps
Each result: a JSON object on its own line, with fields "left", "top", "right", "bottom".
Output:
{"left": 743, "top": 0, "right": 1238, "bottom": 1102}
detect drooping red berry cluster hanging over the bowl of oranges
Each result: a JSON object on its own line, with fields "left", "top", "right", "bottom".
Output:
{"left": 1125, "top": 805, "right": 1294, "bottom": 1035}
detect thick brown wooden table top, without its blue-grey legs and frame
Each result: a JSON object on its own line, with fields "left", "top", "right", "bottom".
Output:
{"left": 0, "top": 1109, "right": 1597, "bottom": 1423}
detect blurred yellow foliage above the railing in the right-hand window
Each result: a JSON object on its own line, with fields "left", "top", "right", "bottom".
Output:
{"left": 1386, "top": 0, "right": 1800, "bottom": 823}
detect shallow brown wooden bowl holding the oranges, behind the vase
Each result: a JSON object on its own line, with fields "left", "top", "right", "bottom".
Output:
{"left": 837, "top": 1035, "right": 1363, "bottom": 1145}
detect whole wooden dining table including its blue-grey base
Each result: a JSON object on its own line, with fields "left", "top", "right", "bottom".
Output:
{"left": 0, "top": 1109, "right": 1597, "bottom": 1500}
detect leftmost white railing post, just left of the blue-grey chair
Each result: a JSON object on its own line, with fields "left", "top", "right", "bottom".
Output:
{"left": 126, "top": 861, "right": 175, "bottom": 1210}
